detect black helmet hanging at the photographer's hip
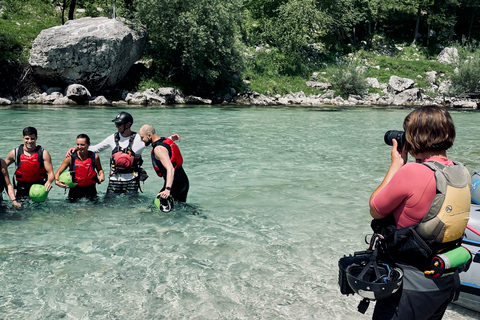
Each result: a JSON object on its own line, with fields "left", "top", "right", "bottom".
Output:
{"left": 347, "top": 262, "right": 403, "bottom": 300}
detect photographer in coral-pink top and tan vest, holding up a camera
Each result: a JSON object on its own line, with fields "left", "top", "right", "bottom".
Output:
{"left": 370, "top": 106, "right": 470, "bottom": 320}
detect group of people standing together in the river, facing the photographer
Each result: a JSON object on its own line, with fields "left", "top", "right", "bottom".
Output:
{"left": 0, "top": 111, "right": 189, "bottom": 207}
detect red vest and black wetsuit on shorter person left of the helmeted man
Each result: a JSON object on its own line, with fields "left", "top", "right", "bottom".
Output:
{"left": 68, "top": 151, "right": 98, "bottom": 201}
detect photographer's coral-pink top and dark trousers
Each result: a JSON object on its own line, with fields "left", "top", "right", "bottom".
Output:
{"left": 372, "top": 157, "right": 470, "bottom": 320}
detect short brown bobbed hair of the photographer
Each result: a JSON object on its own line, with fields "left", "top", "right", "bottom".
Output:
{"left": 403, "top": 106, "right": 455, "bottom": 154}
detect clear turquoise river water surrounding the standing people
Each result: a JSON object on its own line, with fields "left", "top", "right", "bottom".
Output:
{"left": 0, "top": 106, "right": 480, "bottom": 320}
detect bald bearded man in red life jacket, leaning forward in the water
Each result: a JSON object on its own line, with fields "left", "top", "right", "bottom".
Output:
{"left": 138, "top": 124, "right": 189, "bottom": 202}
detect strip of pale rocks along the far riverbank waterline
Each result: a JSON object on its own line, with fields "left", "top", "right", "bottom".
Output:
{"left": 0, "top": 79, "right": 480, "bottom": 109}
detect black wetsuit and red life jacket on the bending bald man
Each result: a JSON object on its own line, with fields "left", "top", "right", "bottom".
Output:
{"left": 151, "top": 138, "right": 190, "bottom": 202}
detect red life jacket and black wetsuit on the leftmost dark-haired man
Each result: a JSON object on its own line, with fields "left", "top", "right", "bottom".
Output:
{"left": 15, "top": 144, "right": 47, "bottom": 199}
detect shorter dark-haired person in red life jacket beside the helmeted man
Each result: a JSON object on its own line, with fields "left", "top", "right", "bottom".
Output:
{"left": 55, "top": 134, "right": 105, "bottom": 201}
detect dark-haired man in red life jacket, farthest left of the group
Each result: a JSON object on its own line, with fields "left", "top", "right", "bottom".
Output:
{"left": 5, "top": 127, "right": 55, "bottom": 201}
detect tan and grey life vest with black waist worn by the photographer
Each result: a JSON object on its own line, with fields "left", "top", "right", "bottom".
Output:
{"left": 371, "top": 161, "right": 471, "bottom": 270}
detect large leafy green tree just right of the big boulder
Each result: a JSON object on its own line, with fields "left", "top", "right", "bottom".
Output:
{"left": 135, "top": 0, "right": 242, "bottom": 93}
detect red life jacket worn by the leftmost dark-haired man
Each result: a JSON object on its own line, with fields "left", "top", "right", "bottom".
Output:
{"left": 15, "top": 144, "right": 47, "bottom": 182}
